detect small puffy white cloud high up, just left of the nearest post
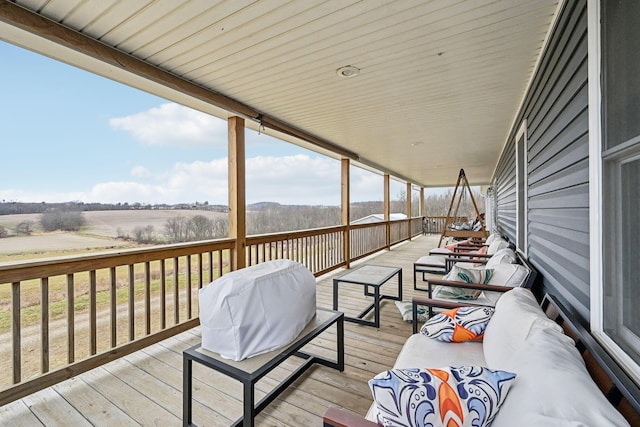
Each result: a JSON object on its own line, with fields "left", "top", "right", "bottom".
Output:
{"left": 109, "top": 103, "right": 227, "bottom": 147}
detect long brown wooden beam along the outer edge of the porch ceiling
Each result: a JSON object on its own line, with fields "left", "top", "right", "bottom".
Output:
{"left": 0, "top": 0, "right": 359, "bottom": 160}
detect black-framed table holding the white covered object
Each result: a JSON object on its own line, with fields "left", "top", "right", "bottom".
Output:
{"left": 182, "top": 308, "right": 344, "bottom": 427}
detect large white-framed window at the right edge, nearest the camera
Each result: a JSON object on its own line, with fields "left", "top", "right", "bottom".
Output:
{"left": 589, "top": 1, "right": 640, "bottom": 381}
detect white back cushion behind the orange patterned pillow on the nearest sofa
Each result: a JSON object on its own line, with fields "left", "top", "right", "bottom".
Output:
{"left": 483, "top": 288, "right": 562, "bottom": 369}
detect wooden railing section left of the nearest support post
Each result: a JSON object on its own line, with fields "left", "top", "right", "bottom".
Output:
{"left": 0, "top": 239, "right": 234, "bottom": 406}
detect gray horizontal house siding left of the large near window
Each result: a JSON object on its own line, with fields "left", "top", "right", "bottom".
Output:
{"left": 494, "top": 1, "right": 589, "bottom": 321}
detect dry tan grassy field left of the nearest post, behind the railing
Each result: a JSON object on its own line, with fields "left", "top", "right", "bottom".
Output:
{"left": 0, "top": 210, "right": 226, "bottom": 388}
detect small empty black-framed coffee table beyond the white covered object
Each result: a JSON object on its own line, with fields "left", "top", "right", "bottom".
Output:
{"left": 333, "top": 264, "right": 402, "bottom": 328}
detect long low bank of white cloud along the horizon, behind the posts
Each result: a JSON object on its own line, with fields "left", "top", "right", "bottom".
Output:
{"left": 0, "top": 154, "right": 383, "bottom": 206}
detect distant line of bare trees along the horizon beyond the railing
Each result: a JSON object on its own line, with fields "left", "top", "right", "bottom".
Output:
{"left": 0, "top": 189, "right": 485, "bottom": 244}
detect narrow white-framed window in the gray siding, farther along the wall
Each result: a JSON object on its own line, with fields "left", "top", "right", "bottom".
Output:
{"left": 516, "top": 120, "right": 527, "bottom": 254}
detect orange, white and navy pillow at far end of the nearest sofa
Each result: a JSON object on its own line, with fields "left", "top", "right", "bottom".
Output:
{"left": 420, "top": 307, "right": 494, "bottom": 342}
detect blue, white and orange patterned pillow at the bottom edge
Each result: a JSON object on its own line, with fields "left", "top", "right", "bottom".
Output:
{"left": 369, "top": 366, "right": 516, "bottom": 427}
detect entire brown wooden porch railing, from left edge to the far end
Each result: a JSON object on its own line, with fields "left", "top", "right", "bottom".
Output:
{"left": 0, "top": 218, "right": 422, "bottom": 406}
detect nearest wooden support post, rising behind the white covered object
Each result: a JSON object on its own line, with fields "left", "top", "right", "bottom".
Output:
{"left": 228, "top": 116, "right": 247, "bottom": 270}
